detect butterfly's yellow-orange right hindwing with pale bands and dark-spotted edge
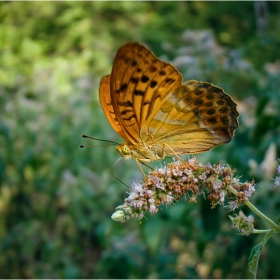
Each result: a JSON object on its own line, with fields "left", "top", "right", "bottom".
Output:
{"left": 142, "top": 80, "right": 238, "bottom": 154}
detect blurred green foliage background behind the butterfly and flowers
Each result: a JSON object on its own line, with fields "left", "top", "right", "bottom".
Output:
{"left": 0, "top": 1, "right": 280, "bottom": 278}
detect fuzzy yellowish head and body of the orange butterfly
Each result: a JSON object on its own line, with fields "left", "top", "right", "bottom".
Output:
{"left": 116, "top": 143, "right": 163, "bottom": 162}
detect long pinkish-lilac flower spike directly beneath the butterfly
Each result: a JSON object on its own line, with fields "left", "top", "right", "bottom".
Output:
{"left": 112, "top": 158, "right": 255, "bottom": 222}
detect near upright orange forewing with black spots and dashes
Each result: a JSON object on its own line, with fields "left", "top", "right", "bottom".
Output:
{"left": 111, "top": 43, "right": 182, "bottom": 144}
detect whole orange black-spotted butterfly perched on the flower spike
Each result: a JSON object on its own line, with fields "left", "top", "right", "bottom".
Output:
{"left": 99, "top": 43, "right": 239, "bottom": 172}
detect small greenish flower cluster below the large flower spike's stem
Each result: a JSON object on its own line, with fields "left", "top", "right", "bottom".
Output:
{"left": 229, "top": 211, "right": 254, "bottom": 236}
